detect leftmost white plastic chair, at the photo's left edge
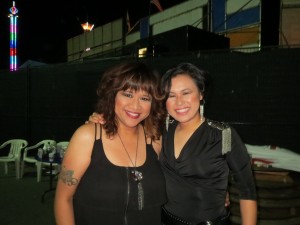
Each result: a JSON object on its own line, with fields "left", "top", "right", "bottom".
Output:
{"left": 0, "top": 139, "right": 28, "bottom": 179}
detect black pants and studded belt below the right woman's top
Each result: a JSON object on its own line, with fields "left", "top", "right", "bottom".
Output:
{"left": 161, "top": 208, "right": 230, "bottom": 225}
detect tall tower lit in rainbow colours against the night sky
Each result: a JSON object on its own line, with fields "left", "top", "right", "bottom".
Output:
{"left": 8, "top": 1, "right": 18, "bottom": 71}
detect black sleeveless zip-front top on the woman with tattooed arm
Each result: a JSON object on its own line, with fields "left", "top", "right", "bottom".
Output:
{"left": 73, "top": 125, "right": 166, "bottom": 225}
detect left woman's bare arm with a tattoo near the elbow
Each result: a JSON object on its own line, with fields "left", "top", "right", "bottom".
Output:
{"left": 54, "top": 123, "right": 95, "bottom": 225}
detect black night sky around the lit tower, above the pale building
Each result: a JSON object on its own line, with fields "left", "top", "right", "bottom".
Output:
{"left": 0, "top": 0, "right": 184, "bottom": 69}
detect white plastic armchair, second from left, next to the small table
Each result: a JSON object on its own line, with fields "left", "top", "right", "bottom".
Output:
{"left": 21, "top": 139, "right": 56, "bottom": 182}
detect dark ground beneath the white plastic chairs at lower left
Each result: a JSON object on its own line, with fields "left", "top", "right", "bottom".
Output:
{"left": 0, "top": 163, "right": 56, "bottom": 225}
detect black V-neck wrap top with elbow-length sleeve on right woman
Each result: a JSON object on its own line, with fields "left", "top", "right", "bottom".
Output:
{"left": 160, "top": 120, "right": 256, "bottom": 224}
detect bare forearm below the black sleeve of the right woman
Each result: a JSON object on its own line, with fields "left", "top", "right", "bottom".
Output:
{"left": 240, "top": 199, "right": 257, "bottom": 225}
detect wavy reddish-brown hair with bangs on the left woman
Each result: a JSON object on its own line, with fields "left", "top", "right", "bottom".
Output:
{"left": 96, "top": 61, "right": 166, "bottom": 140}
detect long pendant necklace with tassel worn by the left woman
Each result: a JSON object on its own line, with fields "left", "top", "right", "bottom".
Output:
{"left": 117, "top": 129, "right": 144, "bottom": 210}
